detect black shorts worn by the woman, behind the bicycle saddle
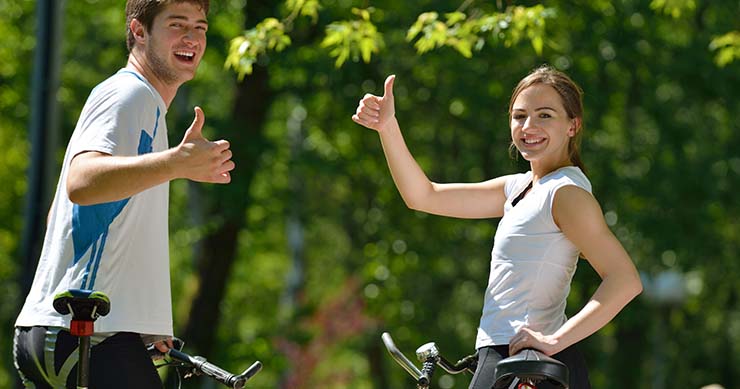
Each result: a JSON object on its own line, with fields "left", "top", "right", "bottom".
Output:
{"left": 469, "top": 345, "right": 591, "bottom": 389}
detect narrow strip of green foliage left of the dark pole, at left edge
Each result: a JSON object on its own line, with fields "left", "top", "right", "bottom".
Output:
{"left": 0, "top": 0, "right": 42, "bottom": 388}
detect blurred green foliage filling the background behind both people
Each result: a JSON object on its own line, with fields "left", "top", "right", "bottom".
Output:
{"left": 0, "top": 0, "right": 740, "bottom": 389}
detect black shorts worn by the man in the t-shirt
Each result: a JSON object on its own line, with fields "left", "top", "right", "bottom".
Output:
{"left": 13, "top": 327, "right": 162, "bottom": 389}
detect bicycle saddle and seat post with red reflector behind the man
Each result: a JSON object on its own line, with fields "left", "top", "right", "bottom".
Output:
{"left": 54, "top": 289, "right": 110, "bottom": 388}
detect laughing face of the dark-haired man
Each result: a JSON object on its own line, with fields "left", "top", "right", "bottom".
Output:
{"left": 146, "top": 2, "right": 208, "bottom": 85}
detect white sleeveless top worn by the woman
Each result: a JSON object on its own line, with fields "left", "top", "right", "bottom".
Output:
{"left": 475, "top": 166, "right": 591, "bottom": 348}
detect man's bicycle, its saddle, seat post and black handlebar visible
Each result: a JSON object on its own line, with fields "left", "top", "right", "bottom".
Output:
{"left": 53, "top": 289, "right": 262, "bottom": 389}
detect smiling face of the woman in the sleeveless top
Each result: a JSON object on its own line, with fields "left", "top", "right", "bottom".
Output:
{"left": 510, "top": 84, "right": 578, "bottom": 165}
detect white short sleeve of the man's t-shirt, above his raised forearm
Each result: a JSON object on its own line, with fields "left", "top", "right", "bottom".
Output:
{"left": 71, "top": 76, "right": 156, "bottom": 156}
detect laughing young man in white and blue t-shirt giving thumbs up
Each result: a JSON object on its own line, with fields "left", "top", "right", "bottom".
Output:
{"left": 14, "top": 0, "right": 234, "bottom": 389}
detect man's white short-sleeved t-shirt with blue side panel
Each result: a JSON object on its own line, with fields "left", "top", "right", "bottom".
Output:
{"left": 16, "top": 69, "right": 172, "bottom": 335}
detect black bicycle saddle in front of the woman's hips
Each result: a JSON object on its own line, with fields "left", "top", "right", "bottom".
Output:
{"left": 493, "top": 349, "right": 568, "bottom": 389}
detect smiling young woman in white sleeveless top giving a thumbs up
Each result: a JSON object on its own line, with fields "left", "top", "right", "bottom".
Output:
{"left": 352, "top": 66, "right": 642, "bottom": 389}
